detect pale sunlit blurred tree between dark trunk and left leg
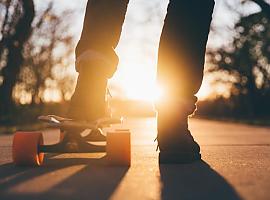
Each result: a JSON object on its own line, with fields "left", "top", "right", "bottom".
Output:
{"left": 15, "top": 4, "right": 74, "bottom": 104}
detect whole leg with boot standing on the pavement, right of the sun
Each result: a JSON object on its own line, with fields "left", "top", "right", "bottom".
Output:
{"left": 156, "top": 0, "right": 214, "bottom": 163}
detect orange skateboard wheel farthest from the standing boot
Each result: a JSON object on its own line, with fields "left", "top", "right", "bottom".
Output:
{"left": 12, "top": 132, "right": 44, "bottom": 166}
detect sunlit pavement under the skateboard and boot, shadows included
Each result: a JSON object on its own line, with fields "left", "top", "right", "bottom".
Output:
{"left": 0, "top": 118, "right": 270, "bottom": 200}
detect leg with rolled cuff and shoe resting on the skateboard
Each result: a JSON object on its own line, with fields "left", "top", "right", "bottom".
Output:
{"left": 68, "top": 0, "right": 128, "bottom": 121}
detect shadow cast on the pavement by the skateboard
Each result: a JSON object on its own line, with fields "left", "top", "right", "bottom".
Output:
{"left": 0, "top": 157, "right": 129, "bottom": 200}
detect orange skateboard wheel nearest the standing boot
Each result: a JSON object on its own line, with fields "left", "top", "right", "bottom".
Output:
{"left": 106, "top": 129, "right": 131, "bottom": 166}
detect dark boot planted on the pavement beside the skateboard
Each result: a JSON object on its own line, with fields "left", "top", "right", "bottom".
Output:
{"left": 157, "top": 99, "right": 201, "bottom": 164}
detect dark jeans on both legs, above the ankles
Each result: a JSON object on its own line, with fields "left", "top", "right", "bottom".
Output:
{"left": 76, "top": 0, "right": 214, "bottom": 108}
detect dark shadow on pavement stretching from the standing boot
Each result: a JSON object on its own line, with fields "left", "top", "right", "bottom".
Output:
{"left": 159, "top": 161, "right": 241, "bottom": 200}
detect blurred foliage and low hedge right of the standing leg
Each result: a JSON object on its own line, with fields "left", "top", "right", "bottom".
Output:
{"left": 200, "top": 0, "right": 270, "bottom": 119}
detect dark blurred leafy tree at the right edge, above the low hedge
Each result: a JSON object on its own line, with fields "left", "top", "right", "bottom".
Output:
{"left": 208, "top": 0, "right": 270, "bottom": 116}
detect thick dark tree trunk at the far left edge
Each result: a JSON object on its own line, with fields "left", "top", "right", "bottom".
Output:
{"left": 0, "top": 0, "right": 35, "bottom": 113}
